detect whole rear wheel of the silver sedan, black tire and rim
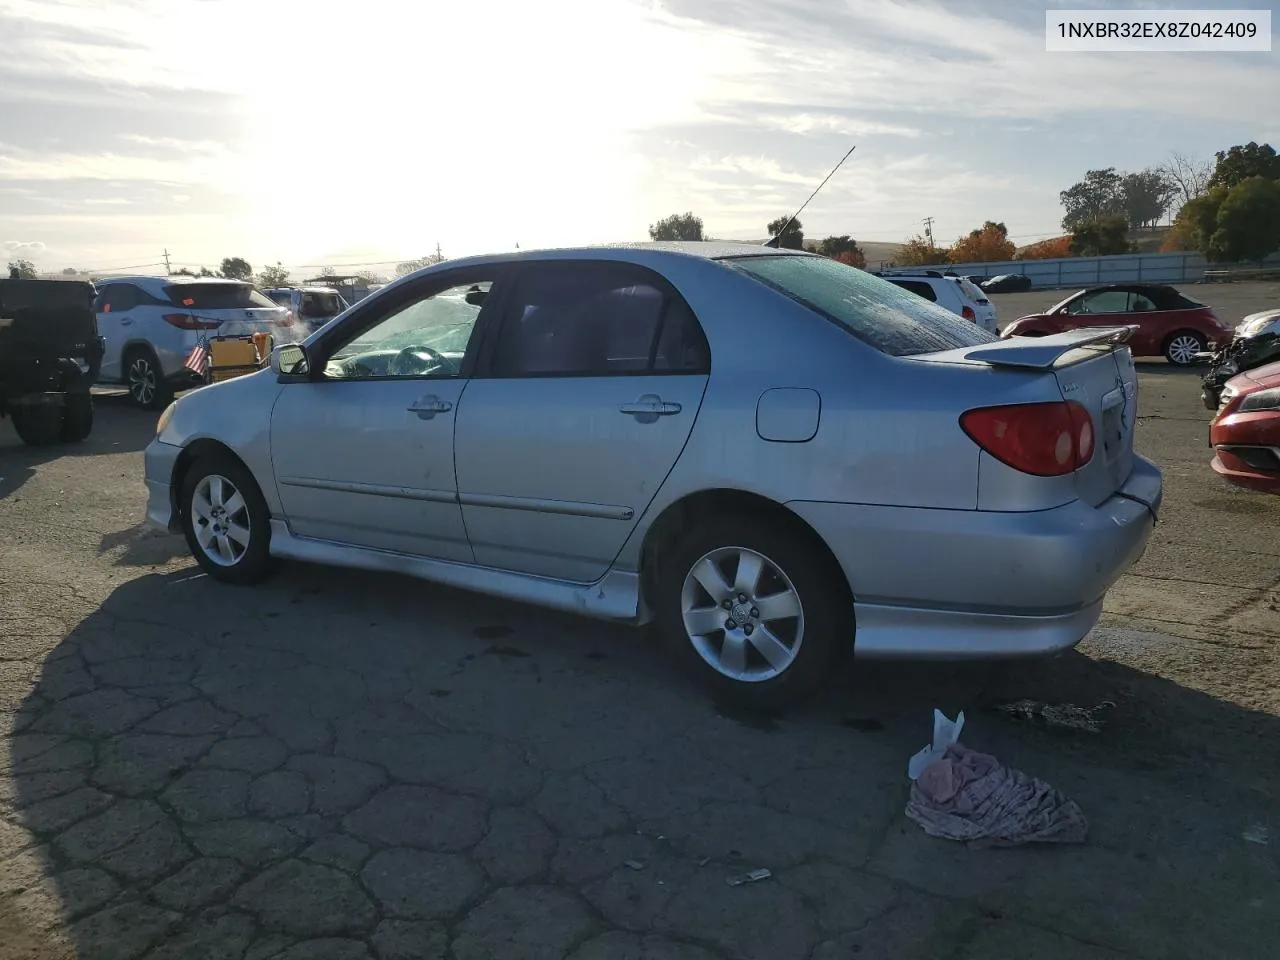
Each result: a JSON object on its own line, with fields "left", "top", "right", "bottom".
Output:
{"left": 655, "top": 515, "right": 854, "bottom": 713}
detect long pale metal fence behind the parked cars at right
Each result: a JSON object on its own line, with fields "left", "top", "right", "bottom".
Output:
{"left": 884, "top": 253, "right": 1280, "bottom": 288}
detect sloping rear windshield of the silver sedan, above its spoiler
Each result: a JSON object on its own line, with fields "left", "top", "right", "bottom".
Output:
{"left": 723, "top": 255, "right": 1000, "bottom": 357}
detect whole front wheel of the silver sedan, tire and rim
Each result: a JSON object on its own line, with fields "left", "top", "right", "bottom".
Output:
{"left": 179, "top": 454, "right": 273, "bottom": 585}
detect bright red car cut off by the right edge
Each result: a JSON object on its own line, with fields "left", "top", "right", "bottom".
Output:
{"left": 1208, "top": 362, "right": 1280, "bottom": 493}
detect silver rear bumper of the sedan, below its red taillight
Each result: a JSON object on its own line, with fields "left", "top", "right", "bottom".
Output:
{"left": 788, "top": 457, "right": 1164, "bottom": 658}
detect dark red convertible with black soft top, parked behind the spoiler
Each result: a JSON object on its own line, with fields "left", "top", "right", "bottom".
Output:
{"left": 1000, "top": 283, "right": 1231, "bottom": 366}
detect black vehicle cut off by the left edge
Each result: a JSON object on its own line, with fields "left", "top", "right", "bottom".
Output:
{"left": 0, "top": 279, "right": 104, "bottom": 447}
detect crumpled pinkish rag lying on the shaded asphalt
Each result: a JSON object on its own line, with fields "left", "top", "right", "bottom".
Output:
{"left": 906, "top": 744, "right": 1089, "bottom": 846}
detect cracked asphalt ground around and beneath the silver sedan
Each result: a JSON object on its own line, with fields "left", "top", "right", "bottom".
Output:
{"left": 0, "top": 281, "right": 1280, "bottom": 960}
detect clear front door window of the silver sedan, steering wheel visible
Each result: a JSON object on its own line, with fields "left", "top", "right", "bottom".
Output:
{"left": 324, "top": 280, "right": 492, "bottom": 380}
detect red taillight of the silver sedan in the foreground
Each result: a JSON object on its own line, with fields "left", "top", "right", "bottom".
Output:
{"left": 960, "top": 401, "right": 1093, "bottom": 476}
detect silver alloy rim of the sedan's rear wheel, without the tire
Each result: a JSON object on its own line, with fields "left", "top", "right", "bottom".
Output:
{"left": 680, "top": 547, "right": 804, "bottom": 682}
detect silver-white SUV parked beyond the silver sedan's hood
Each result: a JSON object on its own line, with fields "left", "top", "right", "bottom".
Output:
{"left": 93, "top": 276, "right": 301, "bottom": 410}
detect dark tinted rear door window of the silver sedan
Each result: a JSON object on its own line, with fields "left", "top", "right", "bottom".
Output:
{"left": 493, "top": 264, "right": 667, "bottom": 376}
